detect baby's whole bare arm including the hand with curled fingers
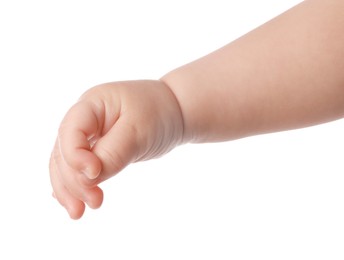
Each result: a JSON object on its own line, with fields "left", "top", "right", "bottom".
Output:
{"left": 50, "top": 0, "right": 344, "bottom": 219}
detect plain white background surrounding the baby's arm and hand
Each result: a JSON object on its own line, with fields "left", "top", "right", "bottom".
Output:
{"left": 0, "top": 0, "right": 344, "bottom": 260}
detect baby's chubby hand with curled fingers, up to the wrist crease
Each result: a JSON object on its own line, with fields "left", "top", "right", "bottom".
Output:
{"left": 50, "top": 80, "right": 183, "bottom": 219}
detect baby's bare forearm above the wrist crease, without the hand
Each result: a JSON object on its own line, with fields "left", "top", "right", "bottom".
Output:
{"left": 162, "top": 0, "right": 344, "bottom": 142}
